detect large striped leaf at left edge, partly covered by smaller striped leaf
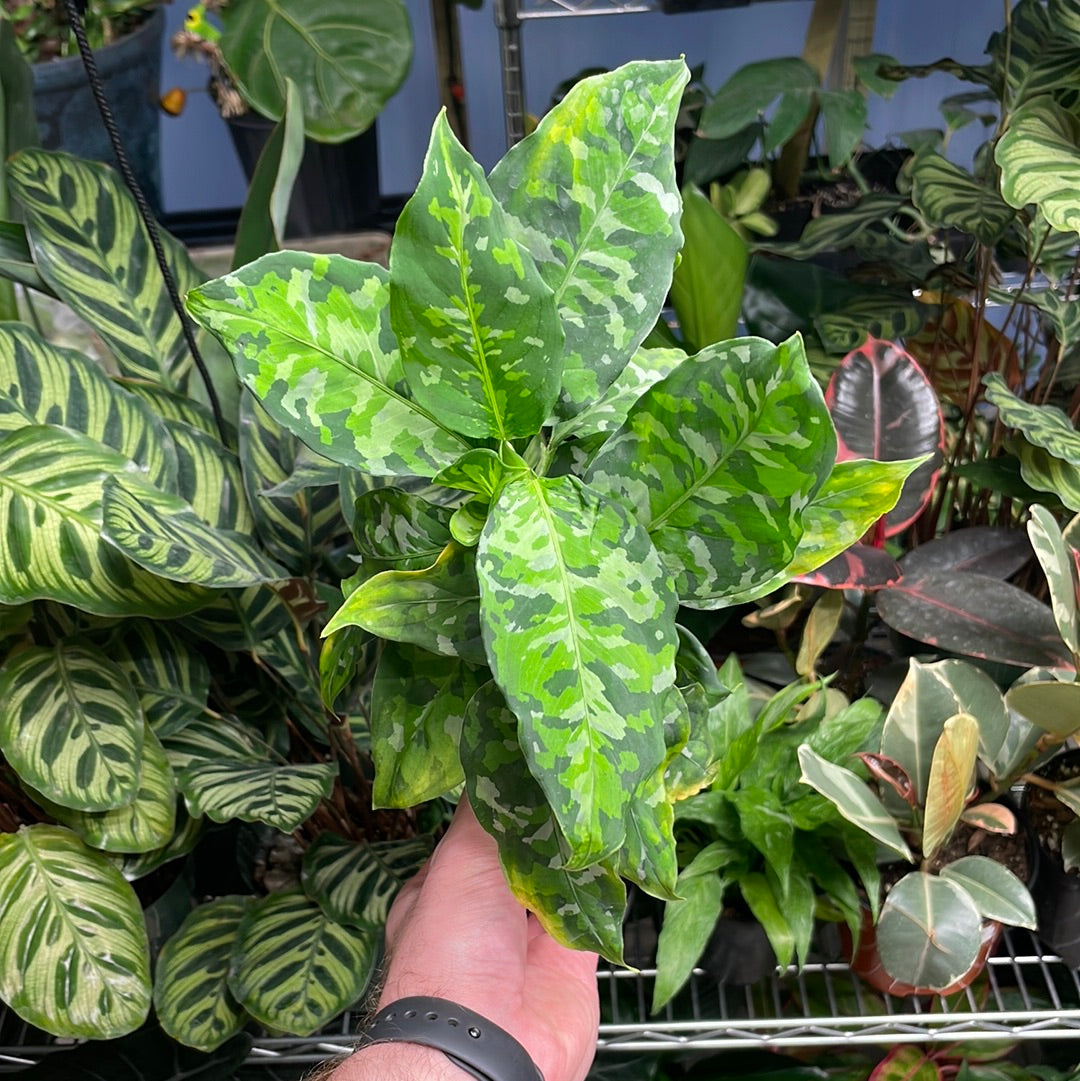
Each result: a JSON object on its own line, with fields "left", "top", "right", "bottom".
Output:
{"left": 0, "top": 426, "right": 205, "bottom": 618}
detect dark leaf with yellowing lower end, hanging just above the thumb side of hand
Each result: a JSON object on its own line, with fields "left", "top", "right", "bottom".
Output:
{"left": 371, "top": 642, "right": 488, "bottom": 808}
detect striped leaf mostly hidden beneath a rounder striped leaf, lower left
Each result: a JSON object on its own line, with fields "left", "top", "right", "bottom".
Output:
{"left": 34, "top": 728, "right": 176, "bottom": 853}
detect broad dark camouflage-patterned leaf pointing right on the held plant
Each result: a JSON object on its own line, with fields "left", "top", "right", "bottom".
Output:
{"left": 586, "top": 337, "right": 836, "bottom": 606}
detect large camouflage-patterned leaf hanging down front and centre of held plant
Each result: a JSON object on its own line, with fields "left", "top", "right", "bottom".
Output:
{"left": 479, "top": 476, "right": 678, "bottom": 868}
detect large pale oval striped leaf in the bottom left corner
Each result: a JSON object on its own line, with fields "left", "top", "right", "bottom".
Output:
{"left": 0, "top": 826, "right": 150, "bottom": 1039}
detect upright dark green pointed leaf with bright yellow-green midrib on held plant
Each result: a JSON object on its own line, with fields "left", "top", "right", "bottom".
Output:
{"left": 390, "top": 112, "right": 562, "bottom": 439}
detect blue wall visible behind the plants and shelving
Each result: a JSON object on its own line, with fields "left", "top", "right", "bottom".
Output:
{"left": 162, "top": 0, "right": 1002, "bottom": 212}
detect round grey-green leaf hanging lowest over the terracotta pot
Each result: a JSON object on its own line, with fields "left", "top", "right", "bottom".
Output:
{"left": 877, "top": 871, "right": 982, "bottom": 990}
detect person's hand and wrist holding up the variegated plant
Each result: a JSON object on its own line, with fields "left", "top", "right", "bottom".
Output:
{"left": 335, "top": 797, "right": 600, "bottom": 1081}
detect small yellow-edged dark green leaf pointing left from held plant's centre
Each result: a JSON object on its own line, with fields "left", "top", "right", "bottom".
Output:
{"left": 323, "top": 542, "right": 485, "bottom": 664}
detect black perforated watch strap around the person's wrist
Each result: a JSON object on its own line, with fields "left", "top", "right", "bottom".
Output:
{"left": 357, "top": 996, "right": 544, "bottom": 1081}
